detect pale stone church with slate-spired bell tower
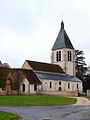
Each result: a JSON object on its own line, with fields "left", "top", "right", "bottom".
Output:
{"left": 20, "top": 21, "right": 83, "bottom": 94}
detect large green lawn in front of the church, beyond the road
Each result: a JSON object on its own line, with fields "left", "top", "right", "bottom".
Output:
{"left": 0, "top": 95, "right": 76, "bottom": 106}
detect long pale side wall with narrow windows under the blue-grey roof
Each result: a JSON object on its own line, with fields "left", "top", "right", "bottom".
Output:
{"left": 42, "top": 79, "right": 82, "bottom": 91}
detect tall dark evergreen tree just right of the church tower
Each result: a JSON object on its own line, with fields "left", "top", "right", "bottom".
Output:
{"left": 75, "top": 50, "right": 87, "bottom": 81}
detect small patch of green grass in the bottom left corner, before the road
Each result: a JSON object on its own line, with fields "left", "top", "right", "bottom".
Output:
{"left": 0, "top": 112, "right": 19, "bottom": 120}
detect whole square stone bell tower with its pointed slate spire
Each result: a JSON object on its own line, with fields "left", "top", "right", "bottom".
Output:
{"left": 51, "top": 21, "right": 75, "bottom": 76}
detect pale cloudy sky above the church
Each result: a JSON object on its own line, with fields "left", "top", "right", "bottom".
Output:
{"left": 0, "top": 0, "right": 90, "bottom": 67}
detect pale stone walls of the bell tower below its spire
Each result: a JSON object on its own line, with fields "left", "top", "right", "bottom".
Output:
{"left": 51, "top": 48, "right": 75, "bottom": 76}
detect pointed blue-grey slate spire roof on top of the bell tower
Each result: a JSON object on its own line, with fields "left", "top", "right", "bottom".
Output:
{"left": 52, "top": 21, "right": 74, "bottom": 50}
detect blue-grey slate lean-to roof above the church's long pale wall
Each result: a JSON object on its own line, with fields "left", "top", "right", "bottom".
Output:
{"left": 35, "top": 72, "right": 81, "bottom": 82}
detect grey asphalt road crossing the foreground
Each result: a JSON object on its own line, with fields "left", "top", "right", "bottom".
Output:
{"left": 0, "top": 97, "right": 90, "bottom": 120}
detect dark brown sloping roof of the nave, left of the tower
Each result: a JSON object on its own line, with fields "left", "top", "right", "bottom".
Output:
{"left": 26, "top": 60, "right": 64, "bottom": 73}
